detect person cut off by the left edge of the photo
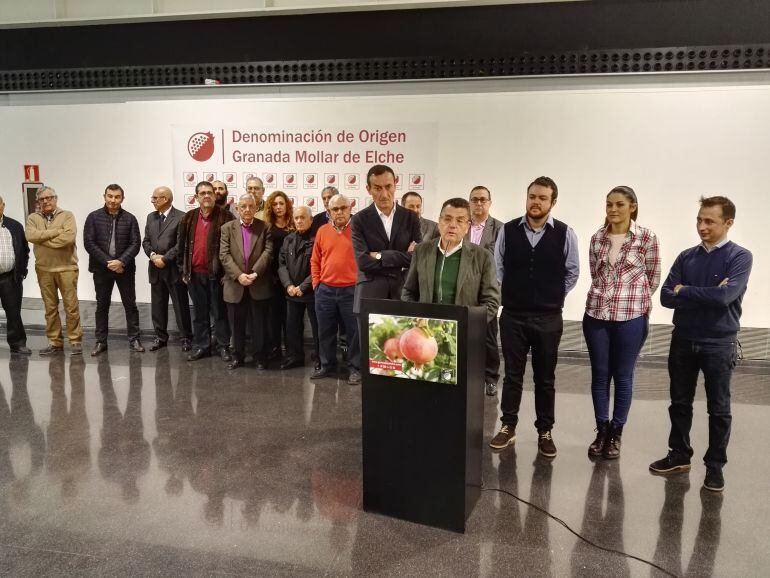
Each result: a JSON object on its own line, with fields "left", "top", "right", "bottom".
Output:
{"left": 0, "top": 197, "right": 32, "bottom": 355}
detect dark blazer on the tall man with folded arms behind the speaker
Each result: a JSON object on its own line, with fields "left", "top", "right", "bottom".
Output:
{"left": 352, "top": 203, "right": 422, "bottom": 283}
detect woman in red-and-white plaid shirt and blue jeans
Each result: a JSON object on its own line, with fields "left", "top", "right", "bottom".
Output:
{"left": 583, "top": 187, "right": 660, "bottom": 459}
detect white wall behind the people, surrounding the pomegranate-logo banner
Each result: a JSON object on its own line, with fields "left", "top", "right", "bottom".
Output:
{"left": 0, "top": 77, "right": 770, "bottom": 327}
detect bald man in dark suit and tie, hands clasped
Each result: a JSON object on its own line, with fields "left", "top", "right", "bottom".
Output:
{"left": 142, "top": 187, "right": 192, "bottom": 351}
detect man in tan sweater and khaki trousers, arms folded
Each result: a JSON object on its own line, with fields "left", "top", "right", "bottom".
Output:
{"left": 25, "top": 187, "right": 83, "bottom": 355}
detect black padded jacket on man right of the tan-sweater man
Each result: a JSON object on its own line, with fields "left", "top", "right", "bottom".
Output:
{"left": 83, "top": 207, "right": 142, "bottom": 273}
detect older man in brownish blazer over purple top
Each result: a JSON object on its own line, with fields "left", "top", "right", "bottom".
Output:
{"left": 219, "top": 193, "right": 273, "bottom": 369}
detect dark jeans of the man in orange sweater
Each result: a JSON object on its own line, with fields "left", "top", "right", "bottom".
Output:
{"left": 315, "top": 283, "right": 361, "bottom": 371}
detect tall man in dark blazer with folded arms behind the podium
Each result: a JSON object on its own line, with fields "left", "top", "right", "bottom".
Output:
{"left": 352, "top": 165, "right": 422, "bottom": 313}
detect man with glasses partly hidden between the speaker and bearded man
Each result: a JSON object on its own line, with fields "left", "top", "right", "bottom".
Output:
{"left": 465, "top": 185, "right": 503, "bottom": 397}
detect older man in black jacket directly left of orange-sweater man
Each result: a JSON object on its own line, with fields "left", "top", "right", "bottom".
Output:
{"left": 278, "top": 206, "right": 320, "bottom": 369}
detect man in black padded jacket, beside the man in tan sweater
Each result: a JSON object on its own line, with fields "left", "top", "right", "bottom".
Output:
{"left": 83, "top": 184, "right": 144, "bottom": 357}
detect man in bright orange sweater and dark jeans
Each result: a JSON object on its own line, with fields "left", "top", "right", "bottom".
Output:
{"left": 310, "top": 195, "right": 361, "bottom": 385}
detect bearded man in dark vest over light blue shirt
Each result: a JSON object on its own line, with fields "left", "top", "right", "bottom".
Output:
{"left": 489, "top": 177, "right": 580, "bottom": 458}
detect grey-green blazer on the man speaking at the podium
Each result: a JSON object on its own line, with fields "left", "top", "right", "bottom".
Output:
{"left": 401, "top": 239, "right": 500, "bottom": 321}
